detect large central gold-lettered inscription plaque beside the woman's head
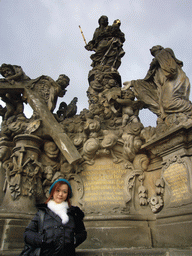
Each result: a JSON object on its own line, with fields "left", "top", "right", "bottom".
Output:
{"left": 81, "top": 157, "right": 126, "bottom": 212}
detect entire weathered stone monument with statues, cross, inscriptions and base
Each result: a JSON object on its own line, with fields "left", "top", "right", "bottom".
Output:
{"left": 0, "top": 16, "right": 192, "bottom": 255}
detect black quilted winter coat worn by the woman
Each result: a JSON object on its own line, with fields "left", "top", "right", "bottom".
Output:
{"left": 24, "top": 204, "right": 87, "bottom": 256}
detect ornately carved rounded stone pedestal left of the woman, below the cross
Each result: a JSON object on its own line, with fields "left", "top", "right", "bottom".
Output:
{"left": 0, "top": 134, "right": 42, "bottom": 213}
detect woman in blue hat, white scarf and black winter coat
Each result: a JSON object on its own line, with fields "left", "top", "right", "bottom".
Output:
{"left": 24, "top": 179, "right": 87, "bottom": 256}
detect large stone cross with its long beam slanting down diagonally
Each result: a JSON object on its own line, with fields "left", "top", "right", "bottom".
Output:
{"left": 0, "top": 79, "right": 81, "bottom": 164}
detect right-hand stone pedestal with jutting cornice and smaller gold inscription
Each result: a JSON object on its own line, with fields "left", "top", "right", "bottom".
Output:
{"left": 143, "top": 125, "right": 192, "bottom": 248}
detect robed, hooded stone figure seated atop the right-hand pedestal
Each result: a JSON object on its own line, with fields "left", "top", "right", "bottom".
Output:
{"left": 124, "top": 45, "right": 192, "bottom": 140}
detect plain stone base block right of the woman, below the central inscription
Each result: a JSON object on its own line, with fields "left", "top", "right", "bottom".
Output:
{"left": 80, "top": 215, "right": 152, "bottom": 249}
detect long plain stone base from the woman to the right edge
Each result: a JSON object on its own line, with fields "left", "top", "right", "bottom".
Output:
{"left": 79, "top": 210, "right": 192, "bottom": 250}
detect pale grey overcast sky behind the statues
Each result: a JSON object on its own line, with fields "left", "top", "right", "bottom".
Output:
{"left": 0, "top": 0, "right": 192, "bottom": 126}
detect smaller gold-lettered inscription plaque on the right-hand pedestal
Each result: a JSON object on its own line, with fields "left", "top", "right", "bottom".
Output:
{"left": 163, "top": 163, "right": 191, "bottom": 204}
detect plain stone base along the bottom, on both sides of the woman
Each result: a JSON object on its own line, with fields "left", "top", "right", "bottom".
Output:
{"left": 0, "top": 211, "right": 192, "bottom": 256}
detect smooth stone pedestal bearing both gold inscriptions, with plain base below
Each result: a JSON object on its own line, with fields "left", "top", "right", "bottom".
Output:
{"left": 0, "top": 125, "right": 192, "bottom": 255}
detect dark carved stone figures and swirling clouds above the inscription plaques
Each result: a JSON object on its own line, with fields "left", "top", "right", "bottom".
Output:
{"left": 0, "top": 16, "right": 192, "bottom": 214}
